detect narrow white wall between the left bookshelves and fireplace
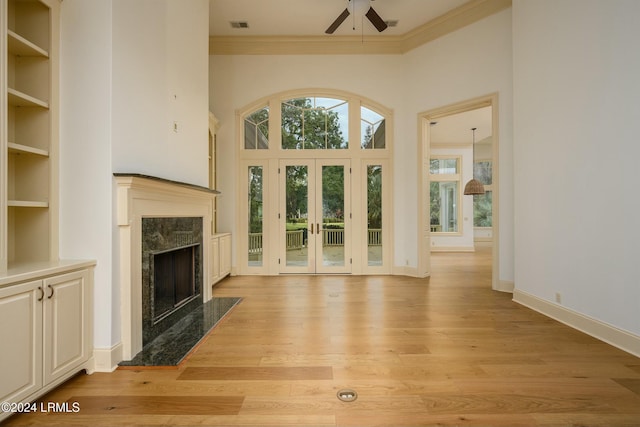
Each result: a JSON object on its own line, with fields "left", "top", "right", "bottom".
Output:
{"left": 60, "top": 0, "right": 114, "bottom": 347}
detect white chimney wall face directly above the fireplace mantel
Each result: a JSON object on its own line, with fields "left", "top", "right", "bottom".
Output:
{"left": 112, "top": 0, "right": 209, "bottom": 186}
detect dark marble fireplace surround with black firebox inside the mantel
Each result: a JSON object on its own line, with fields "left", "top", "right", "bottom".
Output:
{"left": 142, "top": 217, "right": 203, "bottom": 346}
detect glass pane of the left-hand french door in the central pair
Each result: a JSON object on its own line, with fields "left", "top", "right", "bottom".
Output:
{"left": 285, "top": 165, "right": 309, "bottom": 267}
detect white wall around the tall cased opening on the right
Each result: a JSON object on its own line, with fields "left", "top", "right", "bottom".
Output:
{"left": 404, "top": 9, "right": 514, "bottom": 282}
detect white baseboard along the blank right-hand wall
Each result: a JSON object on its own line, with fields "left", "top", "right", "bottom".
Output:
{"left": 513, "top": 289, "right": 640, "bottom": 357}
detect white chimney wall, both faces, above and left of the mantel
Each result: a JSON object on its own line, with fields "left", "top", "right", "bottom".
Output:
{"left": 60, "top": 0, "right": 209, "bottom": 349}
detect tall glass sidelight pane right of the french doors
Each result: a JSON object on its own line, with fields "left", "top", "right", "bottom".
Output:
{"left": 367, "top": 165, "right": 382, "bottom": 265}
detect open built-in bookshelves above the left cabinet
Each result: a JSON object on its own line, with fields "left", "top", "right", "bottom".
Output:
{"left": 0, "top": 0, "right": 59, "bottom": 271}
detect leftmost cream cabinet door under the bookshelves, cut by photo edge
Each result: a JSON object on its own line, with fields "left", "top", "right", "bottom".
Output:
{"left": 0, "top": 280, "right": 44, "bottom": 402}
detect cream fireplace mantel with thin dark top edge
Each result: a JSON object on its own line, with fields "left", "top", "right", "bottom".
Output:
{"left": 114, "top": 174, "right": 218, "bottom": 360}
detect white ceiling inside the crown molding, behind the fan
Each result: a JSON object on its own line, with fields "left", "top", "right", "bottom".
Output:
{"left": 209, "top": 0, "right": 469, "bottom": 36}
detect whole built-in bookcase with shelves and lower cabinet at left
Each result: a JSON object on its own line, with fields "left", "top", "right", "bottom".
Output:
{"left": 0, "top": 4, "right": 95, "bottom": 421}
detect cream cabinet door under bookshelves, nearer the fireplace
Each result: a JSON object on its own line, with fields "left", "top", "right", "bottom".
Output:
{"left": 43, "top": 270, "right": 92, "bottom": 384}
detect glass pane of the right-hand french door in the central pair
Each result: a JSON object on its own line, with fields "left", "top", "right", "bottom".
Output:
{"left": 322, "top": 166, "right": 345, "bottom": 266}
